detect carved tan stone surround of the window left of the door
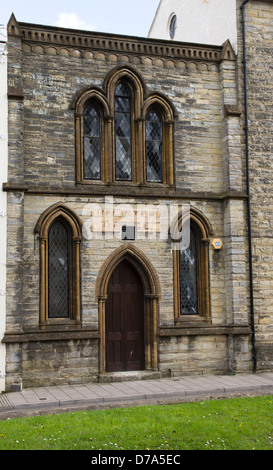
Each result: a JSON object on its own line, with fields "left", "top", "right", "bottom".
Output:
{"left": 35, "top": 202, "right": 82, "bottom": 328}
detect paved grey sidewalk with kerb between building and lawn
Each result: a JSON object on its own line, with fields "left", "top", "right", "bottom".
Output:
{"left": 0, "top": 373, "right": 273, "bottom": 420}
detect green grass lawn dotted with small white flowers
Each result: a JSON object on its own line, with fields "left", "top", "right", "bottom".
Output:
{"left": 0, "top": 396, "right": 273, "bottom": 451}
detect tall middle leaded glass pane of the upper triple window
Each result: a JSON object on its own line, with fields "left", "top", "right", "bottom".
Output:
{"left": 115, "top": 81, "right": 132, "bottom": 181}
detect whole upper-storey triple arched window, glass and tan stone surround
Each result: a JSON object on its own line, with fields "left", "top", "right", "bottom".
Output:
{"left": 72, "top": 67, "right": 177, "bottom": 188}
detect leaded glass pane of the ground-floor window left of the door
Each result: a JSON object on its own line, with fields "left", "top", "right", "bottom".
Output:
{"left": 48, "top": 221, "right": 69, "bottom": 318}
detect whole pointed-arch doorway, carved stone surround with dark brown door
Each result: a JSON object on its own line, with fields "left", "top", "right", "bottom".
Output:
{"left": 96, "top": 244, "right": 160, "bottom": 373}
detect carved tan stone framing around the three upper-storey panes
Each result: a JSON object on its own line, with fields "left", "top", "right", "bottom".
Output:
{"left": 71, "top": 64, "right": 177, "bottom": 187}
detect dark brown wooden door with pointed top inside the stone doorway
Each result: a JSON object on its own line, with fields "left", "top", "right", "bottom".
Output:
{"left": 105, "top": 260, "right": 145, "bottom": 372}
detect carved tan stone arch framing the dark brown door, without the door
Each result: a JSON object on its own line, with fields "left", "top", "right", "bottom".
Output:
{"left": 95, "top": 244, "right": 161, "bottom": 373}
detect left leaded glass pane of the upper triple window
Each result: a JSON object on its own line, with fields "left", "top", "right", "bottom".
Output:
{"left": 83, "top": 102, "right": 101, "bottom": 180}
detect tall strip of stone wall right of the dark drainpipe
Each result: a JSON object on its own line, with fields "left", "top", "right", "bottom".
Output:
{"left": 238, "top": 1, "right": 273, "bottom": 370}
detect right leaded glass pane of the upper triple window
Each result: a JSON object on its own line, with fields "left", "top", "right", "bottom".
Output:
{"left": 145, "top": 108, "right": 163, "bottom": 183}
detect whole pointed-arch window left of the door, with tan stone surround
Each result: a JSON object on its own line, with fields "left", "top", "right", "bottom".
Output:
{"left": 35, "top": 203, "right": 82, "bottom": 327}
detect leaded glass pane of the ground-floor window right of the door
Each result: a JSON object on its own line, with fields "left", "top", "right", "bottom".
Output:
{"left": 179, "top": 229, "right": 198, "bottom": 315}
